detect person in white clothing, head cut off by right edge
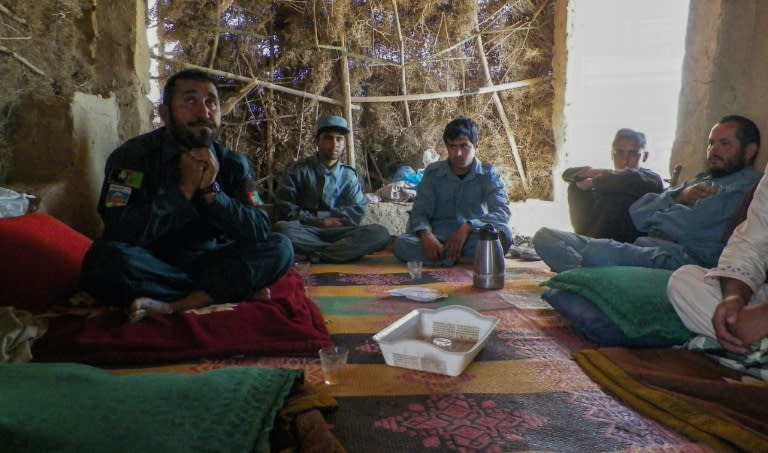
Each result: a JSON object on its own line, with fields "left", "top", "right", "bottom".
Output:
{"left": 667, "top": 169, "right": 768, "bottom": 354}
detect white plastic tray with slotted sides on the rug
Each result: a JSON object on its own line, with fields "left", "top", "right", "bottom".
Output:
{"left": 373, "top": 305, "right": 499, "bottom": 376}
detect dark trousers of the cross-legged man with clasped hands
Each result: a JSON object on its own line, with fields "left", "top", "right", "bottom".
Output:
{"left": 80, "top": 233, "right": 293, "bottom": 306}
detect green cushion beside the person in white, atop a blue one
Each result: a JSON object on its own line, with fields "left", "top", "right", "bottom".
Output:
{"left": 542, "top": 266, "right": 692, "bottom": 343}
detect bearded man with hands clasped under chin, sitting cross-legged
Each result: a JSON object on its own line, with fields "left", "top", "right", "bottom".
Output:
{"left": 80, "top": 70, "right": 293, "bottom": 320}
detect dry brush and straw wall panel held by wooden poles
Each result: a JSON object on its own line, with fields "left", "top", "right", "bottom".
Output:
{"left": 154, "top": 0, "right": 554, "bottom": 199}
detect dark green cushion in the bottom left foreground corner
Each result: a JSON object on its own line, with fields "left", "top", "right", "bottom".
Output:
{"left": 0, "top": 363, "right": 303, "bottom": 453}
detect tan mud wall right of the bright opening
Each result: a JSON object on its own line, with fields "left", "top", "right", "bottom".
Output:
{"left": 670, "top": 0, "right": 768, "bottom": 181}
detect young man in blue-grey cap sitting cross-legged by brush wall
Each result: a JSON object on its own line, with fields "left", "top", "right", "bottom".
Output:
{"left": 274, "top": 116, "right": 389, "bottom": 263}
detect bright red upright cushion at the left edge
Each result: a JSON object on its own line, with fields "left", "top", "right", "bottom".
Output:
{"left": 0, "top": 213, "right": 92, "bottom": 313}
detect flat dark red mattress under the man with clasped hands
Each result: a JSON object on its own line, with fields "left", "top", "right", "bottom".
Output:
{"left": 32, "top": 271, "right": 331, "bottom": 365}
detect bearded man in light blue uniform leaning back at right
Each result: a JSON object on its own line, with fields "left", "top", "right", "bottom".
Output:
{"left": 533, "top": 115, "right": 762, "bottom": 272}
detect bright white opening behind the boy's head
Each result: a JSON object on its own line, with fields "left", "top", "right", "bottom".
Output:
{"left": 555, "top": 0, "right": 689, "bottom": 185}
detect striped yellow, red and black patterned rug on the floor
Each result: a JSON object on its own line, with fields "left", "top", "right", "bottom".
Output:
{"left": 115, "top": 252, "right": 706, "bottom": 453}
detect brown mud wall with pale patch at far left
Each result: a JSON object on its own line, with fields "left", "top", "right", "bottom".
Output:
{"left": 0, "top": 0, "right": 153, "bottom": 237}
